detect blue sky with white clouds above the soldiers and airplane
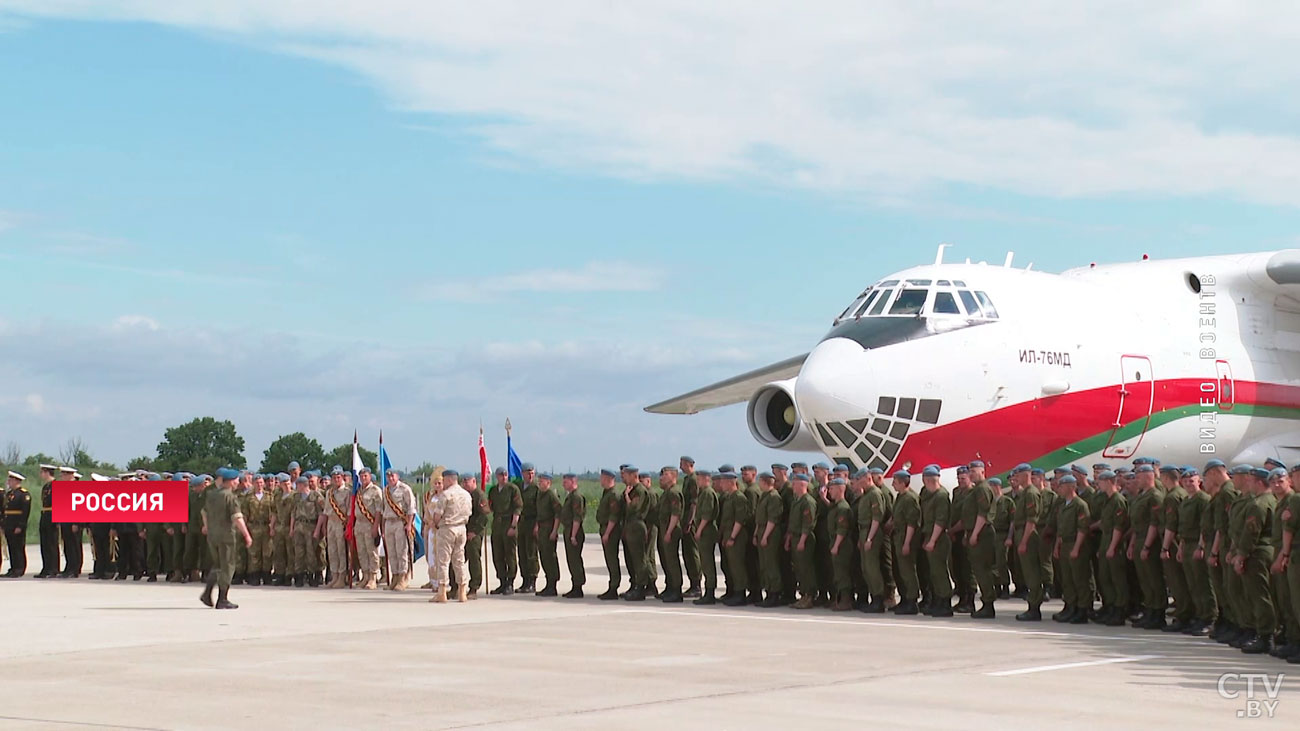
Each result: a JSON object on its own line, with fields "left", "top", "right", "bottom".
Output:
{"left": 0, "top": 0, "right": 1300, "bottom": 468}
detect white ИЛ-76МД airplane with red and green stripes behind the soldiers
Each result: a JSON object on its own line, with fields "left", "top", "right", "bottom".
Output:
{"left": 646, "top": 245, "right": 1300, "bottom": 476}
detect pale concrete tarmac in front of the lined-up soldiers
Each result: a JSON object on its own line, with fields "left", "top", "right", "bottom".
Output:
{"left": 0, "top": 537, "right": 1300, "bottom": 731}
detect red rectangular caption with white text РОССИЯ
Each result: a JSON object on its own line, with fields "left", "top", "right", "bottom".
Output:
{"left": 51, "top": 480, "right": 190, "bottom": 523}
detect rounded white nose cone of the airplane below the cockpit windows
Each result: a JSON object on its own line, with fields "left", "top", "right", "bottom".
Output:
{"left": 794, "top": 338, "right": 870, "bottom": 421}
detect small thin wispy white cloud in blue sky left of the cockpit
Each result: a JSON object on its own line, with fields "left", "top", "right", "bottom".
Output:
{"left": 423, "top": 261, "right": 666, "bottom": 302}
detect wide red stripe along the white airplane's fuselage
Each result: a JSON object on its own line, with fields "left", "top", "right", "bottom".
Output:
{"left": 893, "top": 379, "right": 1300, "bottom": 471}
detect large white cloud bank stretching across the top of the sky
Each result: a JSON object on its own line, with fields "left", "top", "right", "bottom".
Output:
{"left": 0, "top": 0, "right": 1300, "bottom": 204}
